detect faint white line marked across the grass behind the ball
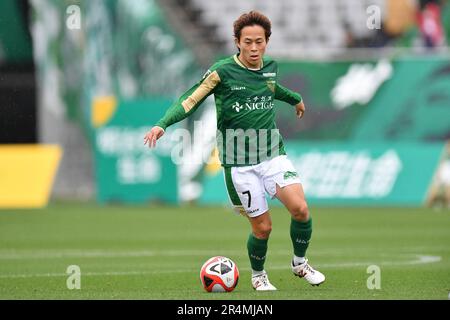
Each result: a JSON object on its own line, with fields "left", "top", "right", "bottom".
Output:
{"left": 0, "top": 255, "right": 442, "bottom": 279}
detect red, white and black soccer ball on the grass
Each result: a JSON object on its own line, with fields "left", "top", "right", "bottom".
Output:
{"left": 200, "top": 256, "right": 239, "bottom": 292}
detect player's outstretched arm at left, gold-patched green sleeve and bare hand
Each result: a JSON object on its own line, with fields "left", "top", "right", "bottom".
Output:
{"left": 144, "top": 70, "right": 220, "bottom": 148}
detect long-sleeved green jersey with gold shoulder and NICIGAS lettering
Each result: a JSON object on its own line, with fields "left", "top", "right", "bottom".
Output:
{"left": 156, "top": 55, "right": 302, "bottom": 167}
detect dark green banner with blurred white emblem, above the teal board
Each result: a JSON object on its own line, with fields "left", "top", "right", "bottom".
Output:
{"left": 277, "top": 55, "right": 450, "bottom": 142}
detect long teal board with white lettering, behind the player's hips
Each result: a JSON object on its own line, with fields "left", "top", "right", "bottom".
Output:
{"left": 201, "top": 142, "right": 444, "bottom": 206}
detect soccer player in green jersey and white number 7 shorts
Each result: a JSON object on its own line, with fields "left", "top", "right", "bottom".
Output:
{"left": 144, "top": 11, "right": 325, "bottom": 291}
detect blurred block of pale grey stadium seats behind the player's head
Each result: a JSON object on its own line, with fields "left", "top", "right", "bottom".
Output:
{"left": 191, "top": 0, "right": 386, "bottom": 56}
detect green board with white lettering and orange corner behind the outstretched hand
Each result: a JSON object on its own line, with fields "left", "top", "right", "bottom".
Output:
{"left": 93, "top": 99, "right": 178, "bottom": 203}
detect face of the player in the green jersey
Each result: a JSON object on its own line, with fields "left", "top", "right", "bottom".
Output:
{"left": 235, "top": 25, "right": 267, "bottom": 69}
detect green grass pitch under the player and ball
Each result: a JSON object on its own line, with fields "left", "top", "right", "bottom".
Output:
{"left": 0, "top": 203, "right": 450, "bottom": 300}
